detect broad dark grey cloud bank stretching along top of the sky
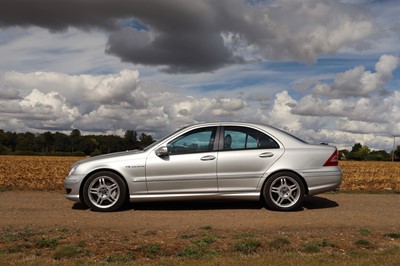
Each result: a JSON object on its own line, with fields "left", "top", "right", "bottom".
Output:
{"left": 0, "top": 0, "right": 374, "bottom": 73}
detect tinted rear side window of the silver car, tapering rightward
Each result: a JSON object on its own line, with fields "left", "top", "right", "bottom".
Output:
{"left": 224, "top": 127, "right": 279, "bottom": 150}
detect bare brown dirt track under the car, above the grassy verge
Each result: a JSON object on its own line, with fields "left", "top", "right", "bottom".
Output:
{"left": 0, "top": 191, "right": 400, "bottom": 232}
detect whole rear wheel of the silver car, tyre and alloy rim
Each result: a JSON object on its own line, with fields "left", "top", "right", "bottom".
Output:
{"left": 263, "top": 172, "right": 305, "bottom": 211}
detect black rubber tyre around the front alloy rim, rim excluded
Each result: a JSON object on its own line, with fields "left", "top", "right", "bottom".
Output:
{"left": 83, "top": 171, "right": 127, "bottom": 212}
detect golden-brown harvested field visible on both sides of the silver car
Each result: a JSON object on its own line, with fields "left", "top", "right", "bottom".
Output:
{"left": 0, "top": 156, "right": 400, "bottom": 192}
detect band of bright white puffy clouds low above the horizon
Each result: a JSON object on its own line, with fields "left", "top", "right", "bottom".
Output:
{"left": 0, "top": 52, "right": 400, "bottom": 150}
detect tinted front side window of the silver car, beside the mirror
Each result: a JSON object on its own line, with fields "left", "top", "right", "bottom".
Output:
{"left": 167, "top": 127, "right": 217, "bottom": 155}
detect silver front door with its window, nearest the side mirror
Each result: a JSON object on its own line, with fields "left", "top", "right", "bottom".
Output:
{"left": 146, "top": 127, "right": 218, "bottom": 193}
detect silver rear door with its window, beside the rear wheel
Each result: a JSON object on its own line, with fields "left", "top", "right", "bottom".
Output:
{"left": 217, "top": 126, "right": 284, "bottom": 192}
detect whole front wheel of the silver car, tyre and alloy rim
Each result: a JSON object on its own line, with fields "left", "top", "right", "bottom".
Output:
{"left": 83, "top": 171, "right": 127, "bottom": 212}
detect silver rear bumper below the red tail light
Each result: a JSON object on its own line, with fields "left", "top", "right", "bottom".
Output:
{"left": 301, "top": 166, "right": 343, "bottom": 196}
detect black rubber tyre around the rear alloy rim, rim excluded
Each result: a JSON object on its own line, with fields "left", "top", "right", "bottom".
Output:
{"left": 263, "top": 172, "right": 305, "bottom": 211}
